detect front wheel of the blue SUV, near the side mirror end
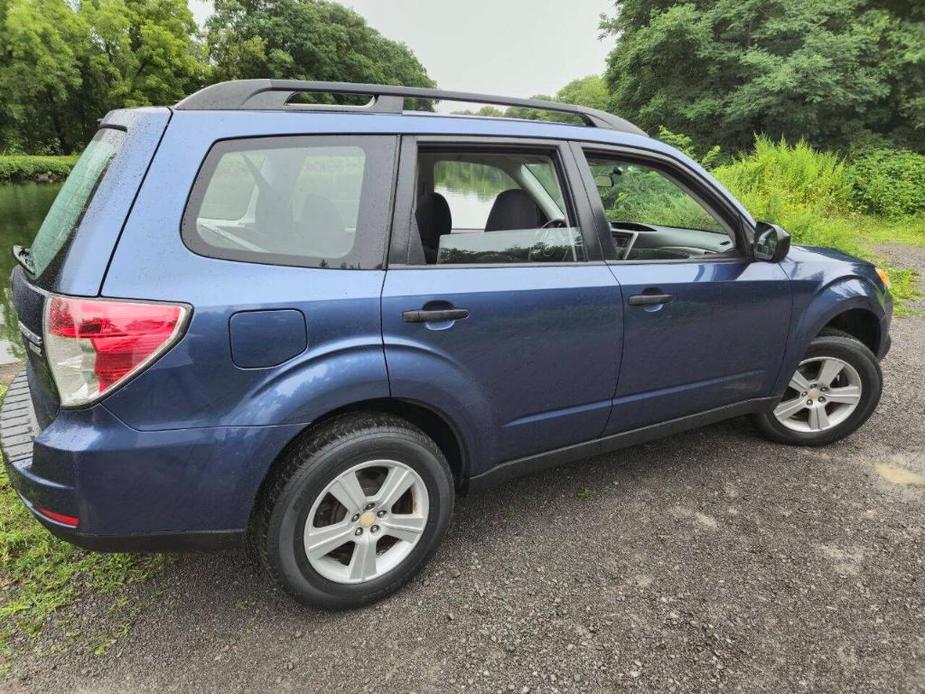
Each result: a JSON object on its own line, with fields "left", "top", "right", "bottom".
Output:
{"left": 752, "top": 329, "right": 883, "bottom": 446}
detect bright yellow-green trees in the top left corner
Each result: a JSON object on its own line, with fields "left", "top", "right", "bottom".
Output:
{"left": 0, "top": 0, "right": 207, "bottom": 153}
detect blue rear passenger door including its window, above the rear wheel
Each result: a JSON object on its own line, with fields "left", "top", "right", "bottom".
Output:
{"left": 382, "top": 138, "right": 622, "bottom": 475}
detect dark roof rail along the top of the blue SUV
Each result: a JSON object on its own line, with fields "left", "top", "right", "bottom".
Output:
{"left": 175, "top": 79, "right": 646, "bottom": 135}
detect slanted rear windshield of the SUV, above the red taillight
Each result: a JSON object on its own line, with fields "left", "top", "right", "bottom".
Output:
{"left": 30, "top": 128, "right": 125, "bottom": 276}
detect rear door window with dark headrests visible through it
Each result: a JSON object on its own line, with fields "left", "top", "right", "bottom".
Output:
{"left": 413, "top": 149, "right": 587, "bottom": 265}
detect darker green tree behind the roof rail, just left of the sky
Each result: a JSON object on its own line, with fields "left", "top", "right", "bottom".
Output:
{"left": 208, "top": 0, "right": 434, "bottom": 108}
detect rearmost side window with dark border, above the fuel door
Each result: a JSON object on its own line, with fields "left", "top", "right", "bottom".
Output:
{"left": 183, "top": 136, "right": 395, "bottom": 269}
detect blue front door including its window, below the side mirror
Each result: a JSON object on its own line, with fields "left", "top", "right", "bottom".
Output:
{"left": 575, "top": 146, "right": 791, "bottom": 434}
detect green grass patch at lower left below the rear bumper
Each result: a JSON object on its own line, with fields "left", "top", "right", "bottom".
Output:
{"left": 0, "top": 386, "right": 170, "bottom": 672}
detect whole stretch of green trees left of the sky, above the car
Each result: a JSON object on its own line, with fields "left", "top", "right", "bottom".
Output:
{"left": 0, "top": 0, "right": 433, "bottom": 154}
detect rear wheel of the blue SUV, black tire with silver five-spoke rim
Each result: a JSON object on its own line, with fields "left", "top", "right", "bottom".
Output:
{"left": 252, "top": 413, "right": 454, "bottom": 609}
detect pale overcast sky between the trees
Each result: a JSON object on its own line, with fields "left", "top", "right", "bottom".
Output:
{"left": 190, "top": 0, "right": 614, "bottom": 108}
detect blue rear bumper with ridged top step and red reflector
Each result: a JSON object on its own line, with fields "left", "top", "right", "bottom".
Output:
{"left": 0, "top": 374, "right": 298, "bottom": 552}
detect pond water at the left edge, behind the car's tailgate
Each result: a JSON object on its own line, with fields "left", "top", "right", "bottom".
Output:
{"left": 0, "top": 183, "right": 61, "bottom": 365}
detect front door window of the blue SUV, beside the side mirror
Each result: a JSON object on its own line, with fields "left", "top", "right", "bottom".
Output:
{"left": 585, "top": 153, "right": 736, "bottom": 260}
